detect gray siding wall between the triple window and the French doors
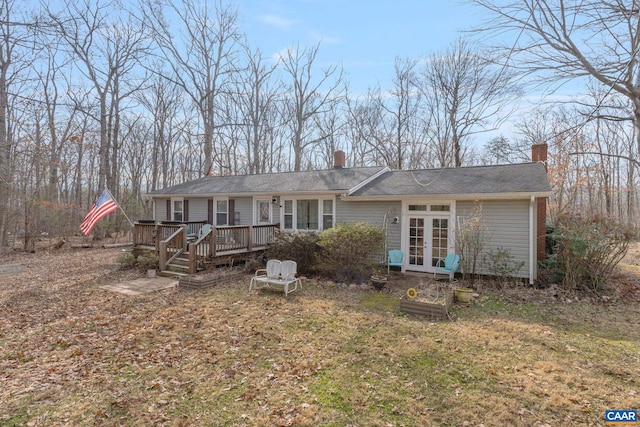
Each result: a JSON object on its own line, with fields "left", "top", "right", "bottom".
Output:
{"left": 336, "top": 197, "right": 402, "bottom": 249}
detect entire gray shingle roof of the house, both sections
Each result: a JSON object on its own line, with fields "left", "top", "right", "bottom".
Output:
{"left": 149, "top": 162, "right": 551, "bottom": 198}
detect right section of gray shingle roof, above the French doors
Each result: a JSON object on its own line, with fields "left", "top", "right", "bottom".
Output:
{"left": 350, "top": 162, "right": 551, "bottom": 197}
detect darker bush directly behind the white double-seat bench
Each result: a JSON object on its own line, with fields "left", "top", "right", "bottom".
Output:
{"left": 265, "top": 233, "right": 319, "bottom": 275}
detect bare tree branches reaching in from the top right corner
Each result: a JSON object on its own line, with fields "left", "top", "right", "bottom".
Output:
{"left": 471, "top": 0, "right": 640, "bottom": 159}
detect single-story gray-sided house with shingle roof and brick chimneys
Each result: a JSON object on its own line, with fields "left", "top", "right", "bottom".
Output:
{"left": 148, "top": 144, "right": 551, "bottom": 283}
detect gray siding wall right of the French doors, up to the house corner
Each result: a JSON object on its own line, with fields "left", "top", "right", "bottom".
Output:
{"left": 456, "top": 200, "right": 530, "bottom": 277}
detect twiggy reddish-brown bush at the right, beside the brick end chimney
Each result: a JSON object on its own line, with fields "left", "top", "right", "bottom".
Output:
{"left": 547, "top": 215, "right": 635, "bottom": 293}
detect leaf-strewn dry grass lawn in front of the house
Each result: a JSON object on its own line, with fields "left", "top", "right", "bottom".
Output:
{"left": 0, "top": 249, "right": 640, "bottom": 426}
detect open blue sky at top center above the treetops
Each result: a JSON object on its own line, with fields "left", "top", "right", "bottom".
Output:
{"left": 235, "top": 0, "right": 481, "bottom": 91}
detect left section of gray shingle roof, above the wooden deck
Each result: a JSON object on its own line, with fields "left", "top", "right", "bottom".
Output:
{"left": 149, "top": 167, "right": 383, "bottom": 196}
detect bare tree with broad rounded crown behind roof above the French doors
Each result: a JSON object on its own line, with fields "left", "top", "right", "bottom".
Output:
{"left": 420, "top": 39, "right": 518, "bottom": 167}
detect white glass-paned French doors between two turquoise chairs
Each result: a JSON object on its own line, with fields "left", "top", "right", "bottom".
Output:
{"left": 407, "top": 215, "right": 449, "bottom": 272}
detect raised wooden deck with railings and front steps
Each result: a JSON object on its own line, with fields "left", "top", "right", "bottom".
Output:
{"left": 133, "top": 221, "right": 280, "bottom": 274}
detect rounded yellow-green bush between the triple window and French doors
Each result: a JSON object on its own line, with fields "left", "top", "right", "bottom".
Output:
{"left": 318, "top": 222, "right": 384, "bottom": 282}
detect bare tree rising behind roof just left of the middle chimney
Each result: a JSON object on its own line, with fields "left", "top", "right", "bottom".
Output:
{"left": 280, "top": 44, "right": 343, "bottom": 171}
